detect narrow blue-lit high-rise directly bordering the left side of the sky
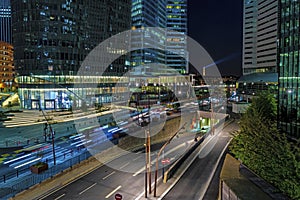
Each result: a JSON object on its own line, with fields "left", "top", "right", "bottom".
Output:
{"left": 166, "top": 0, "right": 188, "bottom": 74}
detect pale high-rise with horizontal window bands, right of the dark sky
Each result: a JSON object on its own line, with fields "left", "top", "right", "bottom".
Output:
{"left": 243, "top": 0, "right": 278, "bottom": 75}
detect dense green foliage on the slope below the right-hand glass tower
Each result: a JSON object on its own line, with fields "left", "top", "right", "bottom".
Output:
{"left": 229, "top": 93, "right": 300, "bottom": 199}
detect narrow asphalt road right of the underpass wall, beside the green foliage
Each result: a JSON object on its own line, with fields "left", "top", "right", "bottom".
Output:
{"left": 163, "top": 120, "right": 238, "bottom": 200}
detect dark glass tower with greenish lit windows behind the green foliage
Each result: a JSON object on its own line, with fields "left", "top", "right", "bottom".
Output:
{"left": 278, "top": 0, "right": 300, "bottom": 139}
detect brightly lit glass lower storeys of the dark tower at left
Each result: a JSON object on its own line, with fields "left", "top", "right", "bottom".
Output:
{"left": 17, "top": 75, "right": 129, "bottom": 109}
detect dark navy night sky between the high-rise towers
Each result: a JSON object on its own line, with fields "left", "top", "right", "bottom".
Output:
{"left": 188, "top": 0, "right": 243, "bottom": 76}
